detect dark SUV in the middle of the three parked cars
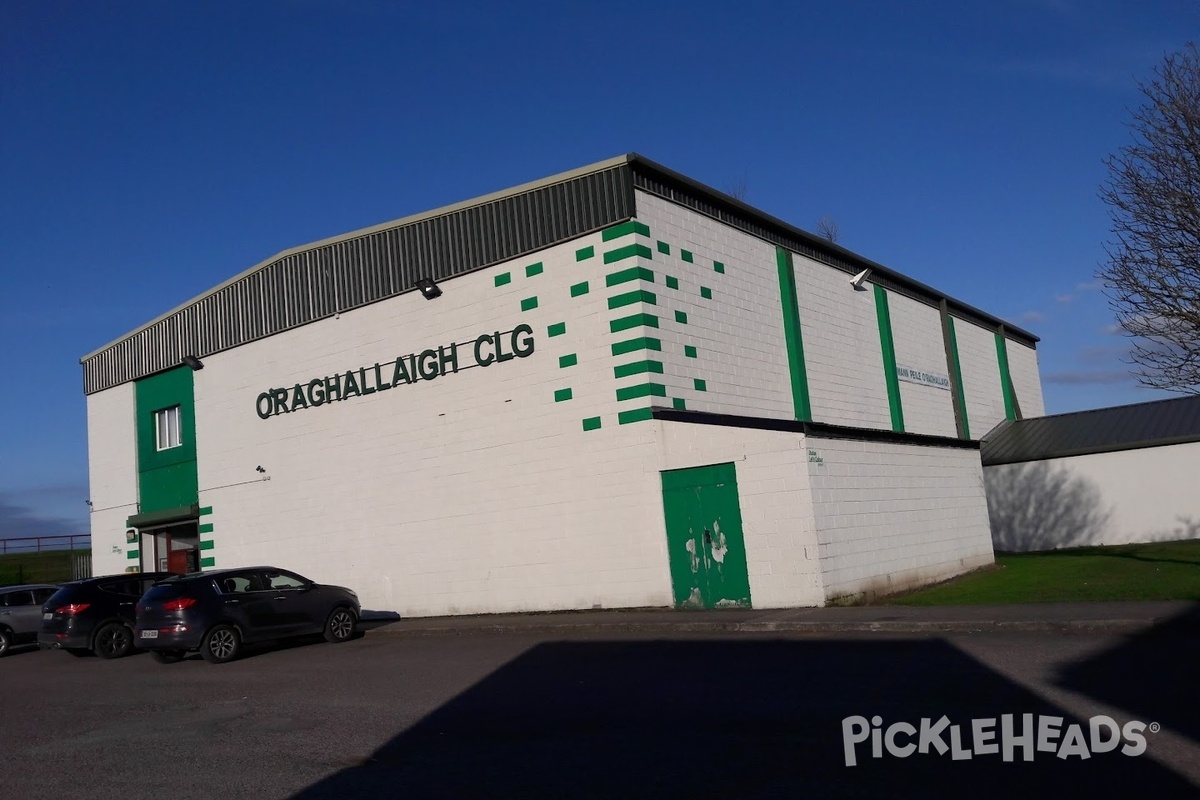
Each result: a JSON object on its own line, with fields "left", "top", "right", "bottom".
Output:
{"left": 37, "top": 572, "right": 173, "bottom": 658}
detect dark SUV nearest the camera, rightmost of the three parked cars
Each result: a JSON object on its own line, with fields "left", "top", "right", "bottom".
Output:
{"left": 134, "top": 566, "right": 361, "bottom": 663}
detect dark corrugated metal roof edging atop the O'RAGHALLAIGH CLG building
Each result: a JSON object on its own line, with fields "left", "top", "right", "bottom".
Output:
{"left": 80, "top": 154, "right": 1038, "bottom": 393}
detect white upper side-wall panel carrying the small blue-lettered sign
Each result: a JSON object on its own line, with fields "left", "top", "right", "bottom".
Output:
{"left": 888, "top": 291, "right": 958, "bottom": 438}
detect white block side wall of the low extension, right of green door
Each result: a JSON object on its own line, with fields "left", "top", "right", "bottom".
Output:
{"left": 808, "top": 437, "right": 994, "bottom": 601}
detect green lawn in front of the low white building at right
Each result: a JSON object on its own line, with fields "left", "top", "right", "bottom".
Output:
{"left": 878, "top": 539, "right": 1200, "bottom": 606}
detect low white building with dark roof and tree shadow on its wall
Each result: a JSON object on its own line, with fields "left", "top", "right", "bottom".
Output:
{"left": 982, "top": 396, "right": 1200, "bottom": 552}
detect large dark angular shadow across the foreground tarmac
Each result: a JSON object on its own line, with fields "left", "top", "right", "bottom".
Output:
{"left": 285, "top": 639, "right": 1195, "bottom": 800}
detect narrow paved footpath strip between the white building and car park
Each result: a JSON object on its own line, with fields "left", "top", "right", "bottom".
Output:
{"left": 362, "top": 601, "right": 1196, "bottom": 636}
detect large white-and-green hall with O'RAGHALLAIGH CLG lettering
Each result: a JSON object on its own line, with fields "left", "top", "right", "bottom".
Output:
{"left": 82, "top": 155, "right": 1042, "bottom": 615}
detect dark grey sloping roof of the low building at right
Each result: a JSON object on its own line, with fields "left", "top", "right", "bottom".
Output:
{"left": 979, "top": 396, "right": 1200, "bottom": 467}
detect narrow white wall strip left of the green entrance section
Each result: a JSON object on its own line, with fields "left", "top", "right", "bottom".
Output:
{"left": 88, "top": 384, "right": 139, "bottom": 575}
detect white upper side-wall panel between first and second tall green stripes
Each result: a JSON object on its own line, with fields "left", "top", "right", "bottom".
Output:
{"left": 792, "top": 253, "right": 892, "bottom": 431}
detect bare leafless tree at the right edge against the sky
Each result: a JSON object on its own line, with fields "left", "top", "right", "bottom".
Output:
{"left": 1098, "top": 42, "right": 1200, "bottom": 393}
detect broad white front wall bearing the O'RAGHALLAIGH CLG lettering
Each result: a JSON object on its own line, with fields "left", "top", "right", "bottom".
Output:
{"left": 196, "top": 227, "right": 671, "bottom": 615}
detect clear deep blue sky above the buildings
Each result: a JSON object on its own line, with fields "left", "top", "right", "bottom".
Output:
{"left": 0, "top": 0, "right": 1200, "bottom": 536}
